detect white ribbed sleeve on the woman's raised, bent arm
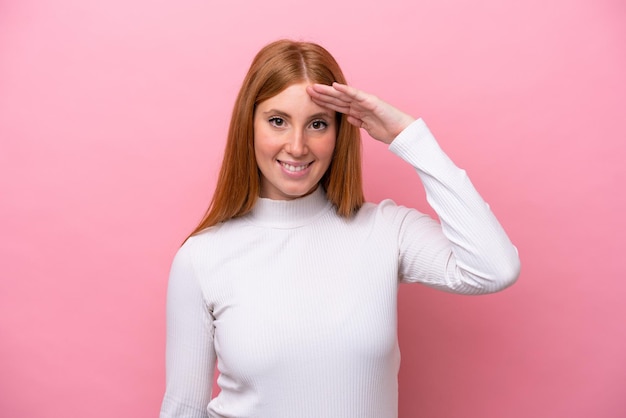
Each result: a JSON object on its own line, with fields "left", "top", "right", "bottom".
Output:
{"left": 389, "top": 119, "right": 520, "bottom": 294}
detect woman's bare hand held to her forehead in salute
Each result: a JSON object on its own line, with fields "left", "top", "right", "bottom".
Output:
{"left": 307, "top": 83, "right": 415, "bottom": 144}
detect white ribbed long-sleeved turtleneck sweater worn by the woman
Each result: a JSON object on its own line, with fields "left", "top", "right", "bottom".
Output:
{"left": 161, "top": 120, "right": 519, "bottom": 418}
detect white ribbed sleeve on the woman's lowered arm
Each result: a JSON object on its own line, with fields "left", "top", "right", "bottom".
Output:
{"left": 160, "top": 241, "right": 215, "bottom": 418}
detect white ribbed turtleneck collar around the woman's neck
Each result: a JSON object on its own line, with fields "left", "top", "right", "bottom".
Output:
{"left": 246, "top": 186, "right": 332, "bottom": 229}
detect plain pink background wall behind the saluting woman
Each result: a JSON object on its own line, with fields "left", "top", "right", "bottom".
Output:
{"left": 0, "top": 0, "right": 626, "bottom": 418}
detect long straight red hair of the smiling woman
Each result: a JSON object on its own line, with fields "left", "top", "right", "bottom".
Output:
{"left": 191, "top": 40, "right": 365, "bottom": 235}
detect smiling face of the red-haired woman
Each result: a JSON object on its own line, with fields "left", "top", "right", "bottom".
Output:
{"left": 254, "top": 83, "right": 337, "bottom": 200}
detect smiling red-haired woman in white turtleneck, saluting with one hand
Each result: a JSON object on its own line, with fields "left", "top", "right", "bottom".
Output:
{"left": 161, "top": 40, "right": 519, "bottom": 418}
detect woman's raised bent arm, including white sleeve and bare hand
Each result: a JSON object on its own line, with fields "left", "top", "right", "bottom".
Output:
{"left": 308, "top": 83, "right": 519, "bottom": 294}
